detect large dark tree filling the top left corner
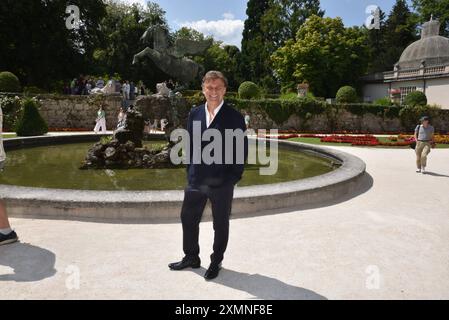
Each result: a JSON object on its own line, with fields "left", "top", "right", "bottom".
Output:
{"left": 0, "top": 0, "right": 105, "bottom": 89}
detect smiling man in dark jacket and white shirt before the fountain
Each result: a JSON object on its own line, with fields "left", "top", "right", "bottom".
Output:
{"left": 169, "top": 71, "right": 248, "bottom": 280}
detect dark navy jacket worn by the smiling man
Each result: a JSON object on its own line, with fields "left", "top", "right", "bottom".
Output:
{"left": 187, "top": 102, "right": 248, "bottom": 187}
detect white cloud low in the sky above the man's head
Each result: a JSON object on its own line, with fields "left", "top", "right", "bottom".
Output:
{"left": 178, "top": 12, "right": 245, "bottom": 48}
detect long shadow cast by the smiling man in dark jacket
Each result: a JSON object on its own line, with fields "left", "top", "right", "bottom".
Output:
{"left": 192, "top": 268, "right": 327, "bottom": 300}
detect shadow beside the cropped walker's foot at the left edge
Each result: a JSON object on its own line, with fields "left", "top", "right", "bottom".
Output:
{"left": 0, "top": 242, "right": 56, "bottom": 282}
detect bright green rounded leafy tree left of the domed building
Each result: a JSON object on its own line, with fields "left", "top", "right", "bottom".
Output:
{"left": 272, "top": 16, "right": 369, "bottom": 97}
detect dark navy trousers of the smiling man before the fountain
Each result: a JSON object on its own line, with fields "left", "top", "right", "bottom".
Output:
{"left": 181, "top": 184, "right": 234, "bottom": 264}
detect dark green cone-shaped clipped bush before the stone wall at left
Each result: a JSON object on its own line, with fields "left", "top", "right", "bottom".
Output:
{"left": 16, "top": 98, "right": 48, "bottom": 137}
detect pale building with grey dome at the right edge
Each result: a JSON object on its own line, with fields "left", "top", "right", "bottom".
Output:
{"left": 362, "top": 19, "right": 449, "bottom": 109}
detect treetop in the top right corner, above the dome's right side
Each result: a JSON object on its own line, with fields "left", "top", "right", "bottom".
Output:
{"left": 413, "top": 0, "right": 449, "bottom": 37}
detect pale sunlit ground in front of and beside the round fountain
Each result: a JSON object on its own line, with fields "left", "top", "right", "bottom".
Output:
{"left": 0, "top": 147, "right": 449, "bottom": 299}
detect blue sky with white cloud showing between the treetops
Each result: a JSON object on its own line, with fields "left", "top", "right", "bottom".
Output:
{"left": 117, "top": 0, "right": 395, "bottom": 47}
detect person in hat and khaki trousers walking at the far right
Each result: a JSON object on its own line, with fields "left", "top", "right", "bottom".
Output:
{"left": 415, "top": 116, "right": 435, "bottom": 173}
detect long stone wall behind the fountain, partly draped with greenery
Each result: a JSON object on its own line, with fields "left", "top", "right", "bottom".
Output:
{"left": 31, "top": 96, "right": 449, "bottom": 133}
